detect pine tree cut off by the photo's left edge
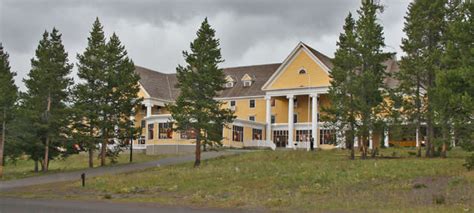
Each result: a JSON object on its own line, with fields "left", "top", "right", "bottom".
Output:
{"left": 0, "top": 43, "right": 18, "bottom": 179}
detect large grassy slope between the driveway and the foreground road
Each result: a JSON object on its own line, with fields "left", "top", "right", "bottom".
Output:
{"left": 1, "top": 148, "right": 474, "bottom": 212}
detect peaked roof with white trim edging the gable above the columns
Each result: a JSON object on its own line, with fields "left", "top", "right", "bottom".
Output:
{"left": 262, "top": 42, "right": 333, "bottom": 91}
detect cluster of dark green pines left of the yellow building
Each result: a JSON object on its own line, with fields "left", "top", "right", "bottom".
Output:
{"left": 0, "top": 18, "right": 141, "bottom": 177}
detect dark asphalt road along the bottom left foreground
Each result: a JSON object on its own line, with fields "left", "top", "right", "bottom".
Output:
{"left": 0, "top": 198, "right": 244, "bottom": 213}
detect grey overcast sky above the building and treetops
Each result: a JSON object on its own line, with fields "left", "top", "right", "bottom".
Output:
{"left": 0, "top": 0, "right": 409, "bottom": 89}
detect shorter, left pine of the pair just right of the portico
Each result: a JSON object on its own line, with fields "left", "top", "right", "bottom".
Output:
{"left": 324, "top": 13, "right": 360, "bottom": 159}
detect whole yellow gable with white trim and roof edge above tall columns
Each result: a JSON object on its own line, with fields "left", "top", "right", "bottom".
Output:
{"left": 262, "top": 42, "right": 332, "bottom": 90}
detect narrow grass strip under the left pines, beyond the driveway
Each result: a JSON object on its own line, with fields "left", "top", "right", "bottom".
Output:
{"left": 0, "top": 153, "right": 165, "bottom": 181}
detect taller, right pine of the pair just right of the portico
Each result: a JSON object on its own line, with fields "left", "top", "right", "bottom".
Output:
{"left": 354, "top": 0, "right": 390, "bottom": 158}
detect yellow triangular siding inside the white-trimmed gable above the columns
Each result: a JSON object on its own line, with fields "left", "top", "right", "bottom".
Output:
{"left": 268, "top": 50, "right": 330, "bottom": 89}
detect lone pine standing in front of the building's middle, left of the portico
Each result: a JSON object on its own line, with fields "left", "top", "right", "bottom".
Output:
{"left": 169, "top": 18, "right": 234, "bottom": 167}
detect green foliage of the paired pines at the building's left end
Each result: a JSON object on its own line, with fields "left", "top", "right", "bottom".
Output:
{"left": 74, "top": 18, "right": 141, "bottom": 166}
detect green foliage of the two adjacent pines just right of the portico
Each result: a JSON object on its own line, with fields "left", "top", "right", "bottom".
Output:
{"left": 326, "top": 1, "right": 390, "bottom": 158}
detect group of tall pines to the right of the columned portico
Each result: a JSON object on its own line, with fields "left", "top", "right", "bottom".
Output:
{"left": 325, "top": 0, "right": 474, "bottom": 159}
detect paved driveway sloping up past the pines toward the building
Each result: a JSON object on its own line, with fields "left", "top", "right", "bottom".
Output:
{"left": 0, "top": 150, "right": 245, "bottom": 191}
